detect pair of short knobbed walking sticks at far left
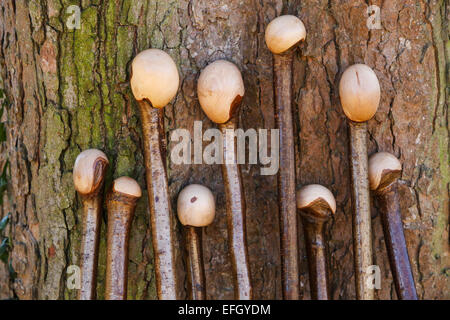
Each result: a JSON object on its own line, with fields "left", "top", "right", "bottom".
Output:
{"left": 73, "top": 149, "right": 141, "bottom": 300}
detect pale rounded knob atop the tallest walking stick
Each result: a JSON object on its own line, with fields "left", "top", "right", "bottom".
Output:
{"left": 265, "top": 15, "right": 306, "bottom": 54}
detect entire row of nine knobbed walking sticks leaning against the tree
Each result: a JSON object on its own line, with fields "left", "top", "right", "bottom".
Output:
{"left": 74, "top": 15, "right": 417, "bottom": 300}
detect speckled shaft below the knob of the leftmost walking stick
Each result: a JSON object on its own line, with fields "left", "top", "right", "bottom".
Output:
{"left": 78, "top": 194, "right": 102, "bottom": 300}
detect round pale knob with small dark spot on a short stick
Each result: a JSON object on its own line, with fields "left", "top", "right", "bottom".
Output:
{"left": 177, "top": 184, "right": 216, "bottom": 227}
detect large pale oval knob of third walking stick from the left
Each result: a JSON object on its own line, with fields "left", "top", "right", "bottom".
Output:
{"left": 130, "top": 49, "right": 180, "bottom": 108}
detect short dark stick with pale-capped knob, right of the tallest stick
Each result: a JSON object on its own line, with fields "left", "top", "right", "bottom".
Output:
{"left": 297, "top": 184, "right": 336, "bottom": 300}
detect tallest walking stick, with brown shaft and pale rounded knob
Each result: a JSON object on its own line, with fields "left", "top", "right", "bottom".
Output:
{"left": 265, "top": 15, "right": 306, "bottom": 300}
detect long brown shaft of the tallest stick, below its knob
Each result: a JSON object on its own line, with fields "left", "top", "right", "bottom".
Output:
{"left": 273, "top": 52, "right": 299, "bottom": 300}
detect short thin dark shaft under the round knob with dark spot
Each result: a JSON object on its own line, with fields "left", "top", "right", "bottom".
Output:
{"left": 186, "top": 226, "right": 206, "bottom": 300}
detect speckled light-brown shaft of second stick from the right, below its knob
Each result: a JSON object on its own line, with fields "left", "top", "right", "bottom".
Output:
{"left": 349, "top": 121, "right": 374, "bottom": 300}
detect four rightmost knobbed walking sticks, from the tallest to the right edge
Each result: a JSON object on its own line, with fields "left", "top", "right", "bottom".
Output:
{"left": 265, "top": 15, "right": 417, "bottom": 300}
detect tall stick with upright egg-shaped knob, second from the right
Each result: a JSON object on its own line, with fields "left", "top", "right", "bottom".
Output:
{"left": 339, "top": 64, "right": 380, "bottom": 300}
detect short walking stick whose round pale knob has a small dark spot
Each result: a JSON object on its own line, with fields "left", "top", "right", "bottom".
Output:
{"left": 177, "top": 184, "right": 216, "bottom": 300}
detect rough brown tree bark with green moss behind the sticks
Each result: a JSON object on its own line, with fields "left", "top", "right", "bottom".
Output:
{"left": 0, "top": 0, "right": 450, "bottom": 299}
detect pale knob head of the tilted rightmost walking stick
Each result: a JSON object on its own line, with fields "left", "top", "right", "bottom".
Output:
{"left": 369, "top": 152, "right": 402, "bottom": 190}
